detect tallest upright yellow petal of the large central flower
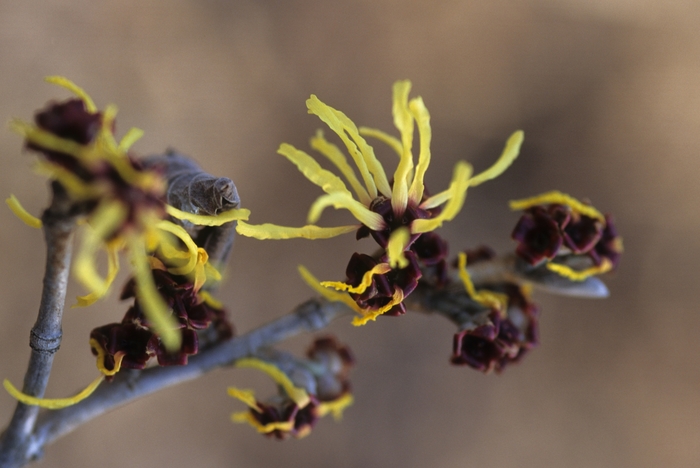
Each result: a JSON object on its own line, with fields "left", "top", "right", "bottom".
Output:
{"left": 391, "top": 80, "right": 413, "bottom": 216}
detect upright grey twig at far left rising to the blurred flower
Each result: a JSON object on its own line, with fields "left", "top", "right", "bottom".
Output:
{"left": 0, "top": 184, "right": 75, "bottom": 467}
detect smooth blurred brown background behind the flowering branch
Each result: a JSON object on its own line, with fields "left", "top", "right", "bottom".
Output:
{"left": 0, "top": 0, "right": 700, "bottom": 467}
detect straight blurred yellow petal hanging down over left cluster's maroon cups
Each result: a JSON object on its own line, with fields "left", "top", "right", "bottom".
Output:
{"left": 128, "top": 235, "right": 182, "bottom": 352}
